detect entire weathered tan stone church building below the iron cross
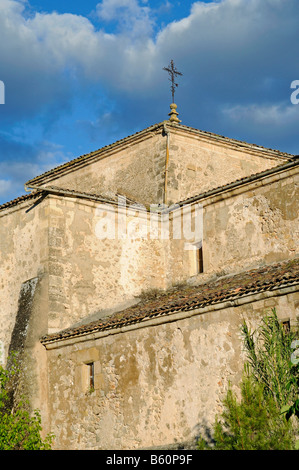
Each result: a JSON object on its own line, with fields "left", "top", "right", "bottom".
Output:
{"left": 0, "top": 117, "right": 299, "bottom": 449}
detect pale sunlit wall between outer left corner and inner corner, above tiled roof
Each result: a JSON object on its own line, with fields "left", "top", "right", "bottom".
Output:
{"left": 49, "top": 196, "right": 168, "bottom": 333}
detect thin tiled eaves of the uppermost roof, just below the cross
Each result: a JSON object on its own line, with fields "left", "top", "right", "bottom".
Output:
{"left": 26, "top": 121, "right": 293, "bottom": 186}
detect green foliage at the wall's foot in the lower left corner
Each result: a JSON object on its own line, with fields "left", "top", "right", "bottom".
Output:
{"left": 0, "top": 354, "right": 53, "bottom": 450}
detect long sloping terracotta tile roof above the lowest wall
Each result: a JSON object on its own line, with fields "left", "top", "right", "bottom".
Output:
{"left": 41, "top": 258, "right": 299, "bottom": 344}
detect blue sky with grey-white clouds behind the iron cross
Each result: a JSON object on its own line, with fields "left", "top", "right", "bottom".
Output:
{"left": 0, "top": 0, "right": 299, "bottom": 204}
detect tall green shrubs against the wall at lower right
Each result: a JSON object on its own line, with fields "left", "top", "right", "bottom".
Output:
{"left": 198, "top": 310, "right": 298, "bottom": 450}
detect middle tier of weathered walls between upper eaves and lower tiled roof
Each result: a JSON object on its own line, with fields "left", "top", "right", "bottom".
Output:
{"left": 0, "top": 163, "right": 298, "bottom": 344}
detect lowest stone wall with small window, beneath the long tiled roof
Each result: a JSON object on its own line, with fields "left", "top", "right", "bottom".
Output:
{"left": 47, "top": 293, "right": 299, "bottom": 450}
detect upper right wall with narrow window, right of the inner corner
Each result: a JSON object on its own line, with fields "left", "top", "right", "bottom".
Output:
{"left": 165, "top": 169, "right": 299, "bottom": 287}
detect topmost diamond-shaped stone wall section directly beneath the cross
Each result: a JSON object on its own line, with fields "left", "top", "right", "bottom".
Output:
{"left": 27, "top": 123, "right": 288, "bottom": 204}
